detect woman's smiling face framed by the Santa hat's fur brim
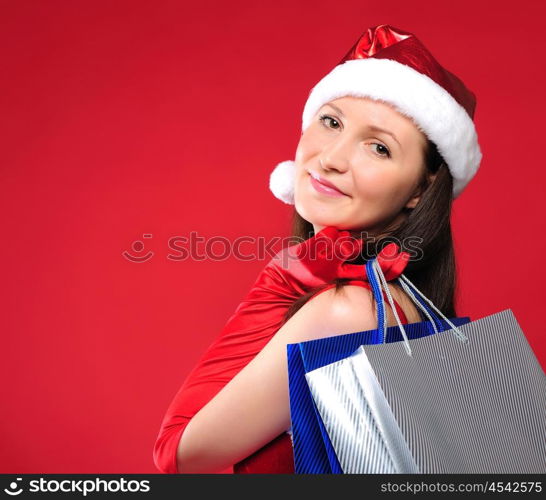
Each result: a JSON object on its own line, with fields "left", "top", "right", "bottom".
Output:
{"left": 294, "top": 96, "right": 427, "bottom": 234}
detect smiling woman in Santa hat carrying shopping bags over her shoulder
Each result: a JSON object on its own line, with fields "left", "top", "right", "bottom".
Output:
{"left": 154, "top": 25, "right": 481, "bottom": 473}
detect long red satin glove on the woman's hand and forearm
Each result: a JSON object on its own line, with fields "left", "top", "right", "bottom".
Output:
{"left": 153, "top": 227, "right": 409, "bottom": 474}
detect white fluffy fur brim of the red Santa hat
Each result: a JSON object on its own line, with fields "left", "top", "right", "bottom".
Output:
{"left": 300, "top": 57, "right": 482, "bottom": 198}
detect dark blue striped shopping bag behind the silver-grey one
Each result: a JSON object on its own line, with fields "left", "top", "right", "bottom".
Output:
{"left": 287, "top": 256, "right": 470, "bottom": 474}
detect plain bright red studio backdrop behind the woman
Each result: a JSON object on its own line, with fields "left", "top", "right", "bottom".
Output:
{"left": 0, "top": 0, "right": 546, "bottom": 473}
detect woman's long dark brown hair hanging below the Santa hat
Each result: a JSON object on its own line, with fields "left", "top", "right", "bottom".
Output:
{"left": 284, "top": 140, "right": 456, "bottom": 322}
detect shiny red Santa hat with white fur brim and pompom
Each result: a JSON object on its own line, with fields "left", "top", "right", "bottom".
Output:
{"left": 269, "top": 24, "right": 482, "bottom": 205}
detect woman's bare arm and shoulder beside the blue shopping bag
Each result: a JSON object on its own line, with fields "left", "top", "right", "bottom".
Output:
{"left": 177, "top": 286, "right": 377, "bottom": 473}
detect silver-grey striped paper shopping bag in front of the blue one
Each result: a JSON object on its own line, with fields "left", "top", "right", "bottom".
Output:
{"left": 305, "top": 270, "right": 546, "bottom": 474}
